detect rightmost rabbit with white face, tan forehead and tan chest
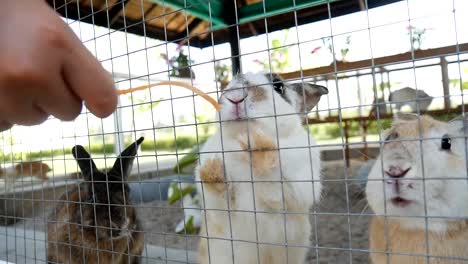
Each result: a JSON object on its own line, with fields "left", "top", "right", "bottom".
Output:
{"left": 366, "top": 114, "right": 468, "bottom": 264}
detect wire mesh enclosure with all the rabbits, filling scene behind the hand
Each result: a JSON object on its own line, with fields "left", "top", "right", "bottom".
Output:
{"left": 0, "top": 0, "right": 468, "bottom": 264}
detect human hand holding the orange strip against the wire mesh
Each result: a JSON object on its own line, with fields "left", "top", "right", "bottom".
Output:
{"left": 0, "top": 0, "right": 117, "bottom": 131}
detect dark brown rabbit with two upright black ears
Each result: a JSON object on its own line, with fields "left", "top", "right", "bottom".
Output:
{"left": 47, "top": 137, "right": 144, "bottom": 264}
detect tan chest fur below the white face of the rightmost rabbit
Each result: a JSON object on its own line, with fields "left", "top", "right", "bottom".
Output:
{"left": 369, "top": 216, "right": 468, "bottom": 264}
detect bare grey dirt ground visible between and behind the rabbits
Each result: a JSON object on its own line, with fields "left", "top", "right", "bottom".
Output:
{"left": 16, "top": 161, "right": 370, "bottom": 263}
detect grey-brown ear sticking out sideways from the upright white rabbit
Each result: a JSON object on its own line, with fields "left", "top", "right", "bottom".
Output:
{"left": 290, "top": 83, "right": 328, "bottom": 113}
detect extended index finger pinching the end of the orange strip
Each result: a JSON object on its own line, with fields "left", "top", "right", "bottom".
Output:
{"left": 63, "top": 28, "right": 117, "bottom": 118}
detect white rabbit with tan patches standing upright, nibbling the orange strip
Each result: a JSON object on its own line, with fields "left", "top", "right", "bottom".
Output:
{"left": 196, "top": 73, "right": 328, "bottom": 264}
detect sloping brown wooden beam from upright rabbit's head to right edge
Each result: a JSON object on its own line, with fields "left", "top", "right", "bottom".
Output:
{"left": 281, "top": 43, "right": 468, "bottom": 79}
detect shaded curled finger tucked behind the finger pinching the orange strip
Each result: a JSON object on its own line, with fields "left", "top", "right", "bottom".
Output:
{"left": 37, "top": 75, "right": 82, "bottom": 121}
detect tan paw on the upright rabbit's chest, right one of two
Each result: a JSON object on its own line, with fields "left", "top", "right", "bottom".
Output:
{"left": 239, "top": 131, "right": 279, "bottom": 175}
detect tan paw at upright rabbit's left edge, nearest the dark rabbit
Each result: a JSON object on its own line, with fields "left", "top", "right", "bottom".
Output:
{"left": 200, "top": 157, "right": 224, "bottom": 191}
